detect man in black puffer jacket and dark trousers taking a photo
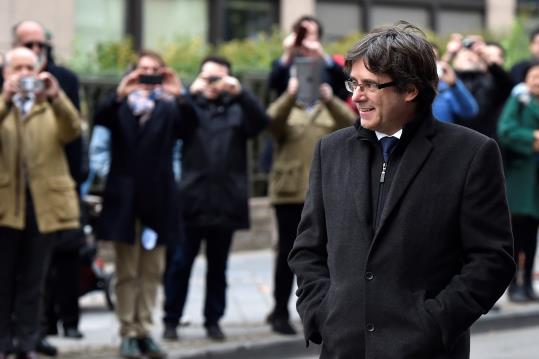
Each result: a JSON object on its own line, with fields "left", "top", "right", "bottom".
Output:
{"left": 163, "top": 56, "right": 268, "bottom": 340}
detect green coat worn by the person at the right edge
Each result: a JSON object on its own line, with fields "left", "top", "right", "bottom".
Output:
{"left": 498, "top": 96, "right": 539, "bottom": 218}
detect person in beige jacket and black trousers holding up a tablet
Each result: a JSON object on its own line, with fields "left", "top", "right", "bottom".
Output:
{"left": 267, "top": 77, "right": 356, "bottom": 335}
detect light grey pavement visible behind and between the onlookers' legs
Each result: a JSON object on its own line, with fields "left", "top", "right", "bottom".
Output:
{"left": 44, "top": 249, "right": 539, "bottom": 359}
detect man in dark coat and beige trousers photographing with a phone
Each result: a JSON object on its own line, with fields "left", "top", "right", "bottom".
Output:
{"left": 94, "top": 51, "right": 190, "bottom": 358}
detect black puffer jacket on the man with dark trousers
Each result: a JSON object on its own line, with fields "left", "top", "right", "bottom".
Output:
{"left": 179, "top": 90, "right": 268, "bottom": 230}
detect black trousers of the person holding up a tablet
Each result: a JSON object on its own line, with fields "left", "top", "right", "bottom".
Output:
{"left": 272, "top": 203, "right": 303, "bottom": 319}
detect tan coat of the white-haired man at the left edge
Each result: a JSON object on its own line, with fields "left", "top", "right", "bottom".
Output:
{"left": 0, "top": 92, "right": 81, "bottom": 233}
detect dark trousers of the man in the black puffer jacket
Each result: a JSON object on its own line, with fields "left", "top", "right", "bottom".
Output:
{"left": 163, "top": 227, "right": 234, "bottom": 325}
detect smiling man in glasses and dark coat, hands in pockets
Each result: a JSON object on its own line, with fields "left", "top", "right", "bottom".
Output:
{"left": 289, "top": 22, "right": 515, "bottom": 359}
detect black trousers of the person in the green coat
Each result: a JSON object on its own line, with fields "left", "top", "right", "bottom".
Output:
{"left": 511, "top": 215, "right": 539, "bottom": 285}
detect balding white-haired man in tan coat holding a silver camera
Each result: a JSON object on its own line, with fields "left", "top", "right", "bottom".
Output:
{"left": 0, "top": 47, "right": 81, "bottom": 359}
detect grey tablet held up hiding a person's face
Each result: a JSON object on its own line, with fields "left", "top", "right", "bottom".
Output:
{"left": 293, "top": 57, "right": 324, "bottom": 106}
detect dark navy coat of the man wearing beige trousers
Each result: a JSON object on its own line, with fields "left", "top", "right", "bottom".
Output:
{"left": 94, "top": 96, "right": 194, "bottom": 244}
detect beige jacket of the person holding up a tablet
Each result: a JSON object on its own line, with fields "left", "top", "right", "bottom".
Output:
{"left": 268, "top": 92, "right": 356, "bottom": 204}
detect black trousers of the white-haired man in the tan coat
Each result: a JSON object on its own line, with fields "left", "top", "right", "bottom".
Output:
{"left": 0, "top": 194, "right": 52, "bottom": 353}
